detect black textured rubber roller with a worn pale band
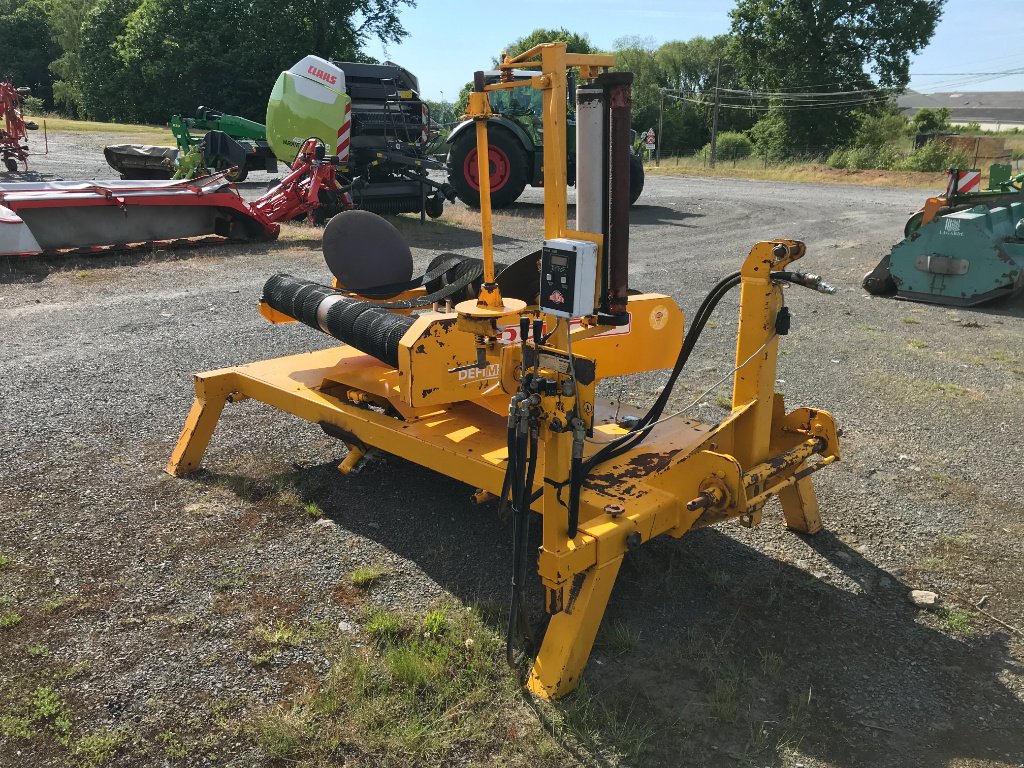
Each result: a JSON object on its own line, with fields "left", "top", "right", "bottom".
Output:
{"left": 263, "top": 274, "right": 415, "bottom": 368}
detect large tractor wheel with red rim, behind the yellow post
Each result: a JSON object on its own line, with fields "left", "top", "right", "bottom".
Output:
{"left": 449, "top": 126, "right": 526, "bottom": 208}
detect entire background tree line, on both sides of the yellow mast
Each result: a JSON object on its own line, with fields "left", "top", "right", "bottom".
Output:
{"left": 0, "top": 0, "right": 945, "bottom": 155}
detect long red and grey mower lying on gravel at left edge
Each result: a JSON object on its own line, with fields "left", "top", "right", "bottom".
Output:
{"left": 0, "top": 139, "right": 351, "bottom": 256}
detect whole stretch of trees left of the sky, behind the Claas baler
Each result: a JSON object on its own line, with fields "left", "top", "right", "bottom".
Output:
{"left": 0, "top": 0, "right": 414, "bottom": 123}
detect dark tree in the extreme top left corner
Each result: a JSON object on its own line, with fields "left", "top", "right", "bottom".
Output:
{"left": 0, "top": 0, "right": 55, "bottom": 103}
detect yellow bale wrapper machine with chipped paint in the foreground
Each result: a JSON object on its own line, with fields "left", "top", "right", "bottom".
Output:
{"left": 167, "top": 43, "right": 839, "bottom": 697}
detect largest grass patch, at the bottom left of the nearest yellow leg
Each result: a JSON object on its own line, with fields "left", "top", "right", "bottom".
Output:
{"left": 253, "top": 607, "right": 561, "bottom": 766}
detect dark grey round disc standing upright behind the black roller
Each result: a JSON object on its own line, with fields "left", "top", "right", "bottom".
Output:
{"left": 324, "top": 211, "right": 413, "bottom": 291}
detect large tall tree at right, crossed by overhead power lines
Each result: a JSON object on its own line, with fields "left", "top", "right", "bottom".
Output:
{"left": 731, "top": 0, "right": 945, "bottom": 153}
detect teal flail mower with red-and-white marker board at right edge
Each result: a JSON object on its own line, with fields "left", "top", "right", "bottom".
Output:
{"left": 862, "top": 167, "right": 1024, "bottom": 306}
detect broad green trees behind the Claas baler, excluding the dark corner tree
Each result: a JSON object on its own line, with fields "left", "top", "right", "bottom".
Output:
{"left": 69, "top": 0, "right": 411, "bottom": 123}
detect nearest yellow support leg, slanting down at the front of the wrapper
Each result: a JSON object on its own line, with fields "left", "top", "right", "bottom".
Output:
{"left": 526, "top": 557, "right": 623, "bottom": 698}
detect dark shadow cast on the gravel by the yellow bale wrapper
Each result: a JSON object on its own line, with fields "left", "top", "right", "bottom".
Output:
{"left": 207, "top": 457, "right": 1024, "bottom": 768}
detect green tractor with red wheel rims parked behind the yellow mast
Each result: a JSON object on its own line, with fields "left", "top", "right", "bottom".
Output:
{"left": 446, "top": 70, "right": 644, "bottom": 208}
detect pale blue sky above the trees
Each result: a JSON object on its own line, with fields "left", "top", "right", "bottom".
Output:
{"left": 366, "top": 0, "right": 1024, "bottom": 101}
